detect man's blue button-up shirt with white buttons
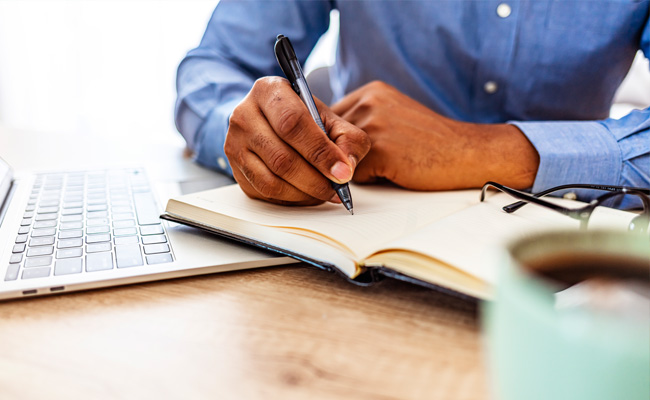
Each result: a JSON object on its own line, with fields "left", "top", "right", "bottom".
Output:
{"left": 176, "top": 0, "right": 650, "bottom": 209}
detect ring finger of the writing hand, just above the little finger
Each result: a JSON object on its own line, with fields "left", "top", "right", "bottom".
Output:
{"left": 248, "top": 122, "right": 334, "bottom": 201}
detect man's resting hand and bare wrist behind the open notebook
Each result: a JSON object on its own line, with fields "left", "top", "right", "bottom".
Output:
{"left": 331, "top": 81, "right": 539, "bottom": 190}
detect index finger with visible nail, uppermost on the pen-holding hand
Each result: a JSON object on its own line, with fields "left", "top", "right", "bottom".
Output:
{"left": 256, "top": 78, "right": 352, "bottom": 183}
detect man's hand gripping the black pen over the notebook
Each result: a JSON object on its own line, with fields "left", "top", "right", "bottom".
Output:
{"left": 224, "top": 77, "right": 370, "bottom": 205}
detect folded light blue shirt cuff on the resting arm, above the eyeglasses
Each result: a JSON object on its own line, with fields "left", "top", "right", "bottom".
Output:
{"left": 508, "top": 121, "right": 622, "bottom": 193}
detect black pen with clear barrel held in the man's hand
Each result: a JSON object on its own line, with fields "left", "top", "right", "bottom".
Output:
{"left": 274, "top": 35, "right": 354, "bottom": 215}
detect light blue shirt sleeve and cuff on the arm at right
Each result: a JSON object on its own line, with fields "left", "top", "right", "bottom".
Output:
{"left": 510, "top": 15, "right": 650, "bottom": 208}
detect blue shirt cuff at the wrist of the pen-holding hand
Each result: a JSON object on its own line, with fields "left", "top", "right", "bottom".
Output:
{"left": 194, "top": 99, "right": 240, "bottom": 176}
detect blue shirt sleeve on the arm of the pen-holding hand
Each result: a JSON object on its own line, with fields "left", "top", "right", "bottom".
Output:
{"left": 175, "top": 0, "right": 332, "bottom": 176}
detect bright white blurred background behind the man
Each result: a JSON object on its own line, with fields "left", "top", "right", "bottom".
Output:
{"left": 0, "top": 0, "right": 650, "bottom": 147}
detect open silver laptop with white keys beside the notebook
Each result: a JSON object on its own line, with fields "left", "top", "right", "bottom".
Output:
{"left": 0, "top": 159, "right": 295, "bottom": 300}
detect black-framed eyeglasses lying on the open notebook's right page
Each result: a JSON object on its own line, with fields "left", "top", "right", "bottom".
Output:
{"left": 481, "top": 181, "right": 650, "bottom": 233}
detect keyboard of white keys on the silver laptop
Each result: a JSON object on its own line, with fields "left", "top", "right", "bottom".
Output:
{"left": 5, "top": 169, "right": 174, "bottom": 281}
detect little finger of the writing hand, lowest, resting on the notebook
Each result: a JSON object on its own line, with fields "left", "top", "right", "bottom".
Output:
{"left": 233, "top": 151, "right": 322, "bottom": 205}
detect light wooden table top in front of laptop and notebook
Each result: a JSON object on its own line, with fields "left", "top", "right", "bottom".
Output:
{"left": 0, "top": 126, "right": 489, "bottom": 399}
